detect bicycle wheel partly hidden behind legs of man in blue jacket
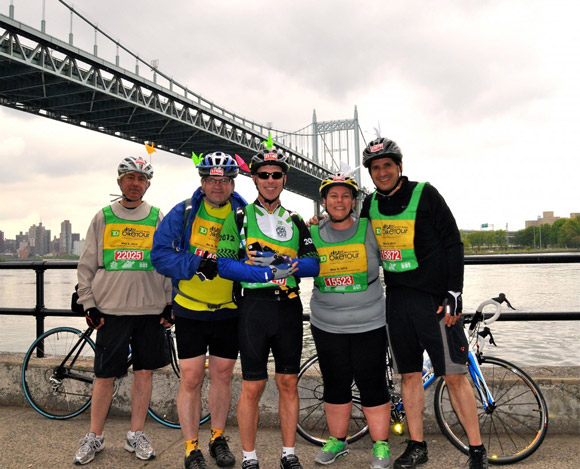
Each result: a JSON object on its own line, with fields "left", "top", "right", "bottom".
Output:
{"left": 148, "top": 329, "right": 210, "bottom": 428}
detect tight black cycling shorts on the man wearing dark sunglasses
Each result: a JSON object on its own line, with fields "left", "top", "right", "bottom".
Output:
{"left": 238, "top": 296, "right": 302, "bottom": 381}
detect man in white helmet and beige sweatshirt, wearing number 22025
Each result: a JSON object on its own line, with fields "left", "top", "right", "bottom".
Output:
{"left": 74, "top": 157, "right": 171, "bottom": 464}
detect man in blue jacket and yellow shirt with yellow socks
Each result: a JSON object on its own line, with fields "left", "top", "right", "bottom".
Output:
{"left": 151, "top": 152, "right": 246, "bottom": 469}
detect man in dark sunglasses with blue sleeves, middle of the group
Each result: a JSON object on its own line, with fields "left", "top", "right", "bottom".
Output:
{"left": 218, "top": 149, "right": 319, "bottom": 469}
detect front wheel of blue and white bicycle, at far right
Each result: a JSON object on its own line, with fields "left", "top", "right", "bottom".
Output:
{"left": 434, "top": 357, "right": 548, "bottom": 464}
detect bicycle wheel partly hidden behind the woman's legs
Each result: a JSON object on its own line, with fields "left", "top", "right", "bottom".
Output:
{"left": 297, "top": 355, "right": 369, "bottom": 446}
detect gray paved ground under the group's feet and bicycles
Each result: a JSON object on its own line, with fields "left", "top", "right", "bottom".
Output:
{"left": 0, "top": 407, "right": 580, "bottom": 469}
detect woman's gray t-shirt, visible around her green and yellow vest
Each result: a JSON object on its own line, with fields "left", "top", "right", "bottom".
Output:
{"left": 310, "top": 217, "right": 386, "bottom": 334}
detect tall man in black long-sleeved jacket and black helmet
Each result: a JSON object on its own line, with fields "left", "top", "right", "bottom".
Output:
{"left": 361, "top": 138, "right": 487, "bottom": 469}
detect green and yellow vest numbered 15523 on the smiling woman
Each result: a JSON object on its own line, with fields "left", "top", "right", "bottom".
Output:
{"left": 310, "top": 218, "right": 368, "bottom": 293}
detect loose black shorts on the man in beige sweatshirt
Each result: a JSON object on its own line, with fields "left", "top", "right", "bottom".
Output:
{"left": 95, "top": 314, "right": 170, "bottom": 378}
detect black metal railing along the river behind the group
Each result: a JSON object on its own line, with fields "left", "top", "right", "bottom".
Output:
{"left": 0, "top": 253, "right": 580, "bottom": 337}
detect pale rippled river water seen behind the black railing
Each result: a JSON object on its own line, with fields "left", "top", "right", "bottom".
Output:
{"left": 0, "top": 264, "right": 580, "bottom": 366}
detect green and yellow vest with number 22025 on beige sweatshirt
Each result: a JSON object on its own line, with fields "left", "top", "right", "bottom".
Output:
{"left": 103, "top": 206, "right": 159, "bottom": 271}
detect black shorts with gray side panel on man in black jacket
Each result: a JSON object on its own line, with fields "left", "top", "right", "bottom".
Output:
{"left": 386, "top": 287, "right": 469, "bottom": 376}
